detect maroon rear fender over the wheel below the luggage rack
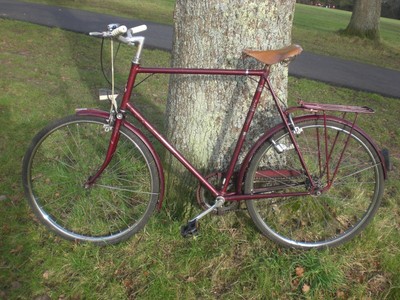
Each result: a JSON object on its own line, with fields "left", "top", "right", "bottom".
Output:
{"left": 236, "top": 115, "right": 387, "bottom": 191}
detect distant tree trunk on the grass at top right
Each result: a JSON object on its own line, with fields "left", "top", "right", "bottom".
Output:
{"left": 346, "top": 0, "right": 382, "bottom": 40}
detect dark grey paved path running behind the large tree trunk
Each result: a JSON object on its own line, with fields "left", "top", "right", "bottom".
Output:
{"left": 0, "top": 0, "right": 400, "bottom": 98}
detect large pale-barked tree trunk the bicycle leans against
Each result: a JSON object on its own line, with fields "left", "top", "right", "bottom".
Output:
{"left": 166, "top": 0, "right": 295, "bottom": 175}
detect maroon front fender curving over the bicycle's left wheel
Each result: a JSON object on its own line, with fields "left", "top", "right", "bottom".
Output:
{"left": 76, "top": 108, "right": 165, "bottom": 210}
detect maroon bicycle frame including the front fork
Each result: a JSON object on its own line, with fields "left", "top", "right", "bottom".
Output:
{"left": 82, "top": 63, "right": 334, "bottom": 206}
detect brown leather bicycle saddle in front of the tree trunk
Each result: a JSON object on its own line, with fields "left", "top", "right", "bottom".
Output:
{"left": 243, "top": 44, "right": 303, "bottom": 65}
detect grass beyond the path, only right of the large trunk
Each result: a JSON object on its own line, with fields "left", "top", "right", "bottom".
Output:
{"left": 293, "top": 4, "right": 400, "bottom": 70}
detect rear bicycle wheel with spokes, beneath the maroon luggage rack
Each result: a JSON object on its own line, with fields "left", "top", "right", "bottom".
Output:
{"left": 245, "top": 116, "right": 384, "bottom": 249}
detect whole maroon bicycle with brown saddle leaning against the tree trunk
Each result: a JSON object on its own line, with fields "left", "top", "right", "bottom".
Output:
{"left": 22, "top": 24, "right": 390, "bottom": 249}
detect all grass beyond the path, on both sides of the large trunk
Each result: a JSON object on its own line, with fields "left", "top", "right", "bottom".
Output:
{"left": 21, "top": 0, "right": 400, "bottom": 70}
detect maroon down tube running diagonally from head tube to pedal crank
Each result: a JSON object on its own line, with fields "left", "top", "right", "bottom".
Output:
{"left": 126, "top": 103, "right": 220, "bottom": 197}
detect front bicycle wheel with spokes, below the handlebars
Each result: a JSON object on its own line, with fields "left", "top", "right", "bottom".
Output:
{"left": 22, "top": 115, "right": 160, "bottom": 244}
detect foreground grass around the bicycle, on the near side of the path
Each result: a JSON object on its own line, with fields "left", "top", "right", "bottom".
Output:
{"left": 0, "top": 19, "right": 400, "bottom": 299}
